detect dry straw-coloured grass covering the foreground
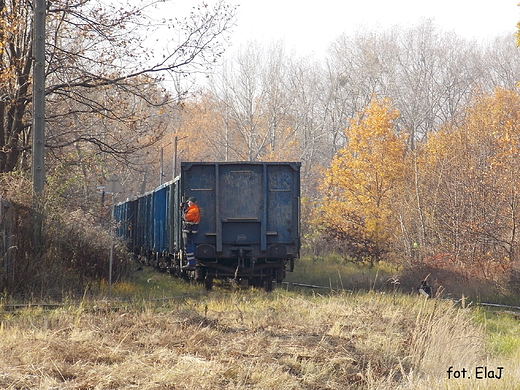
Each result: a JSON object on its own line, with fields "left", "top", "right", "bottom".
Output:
{"left": 0, "top": 284, "right": 520, "bottom": 389}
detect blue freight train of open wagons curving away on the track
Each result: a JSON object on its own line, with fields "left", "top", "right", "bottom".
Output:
{"left": 114, "top": 162, "right": 300, "bottom": 291}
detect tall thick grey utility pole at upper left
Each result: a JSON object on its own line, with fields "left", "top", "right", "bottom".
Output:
{"left": 32, "top": 0, "right": 46, "bottom": 195}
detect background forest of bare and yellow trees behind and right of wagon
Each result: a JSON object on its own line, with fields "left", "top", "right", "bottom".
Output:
{"left": 149, "top": 21, "right": 520, "bottom": 293}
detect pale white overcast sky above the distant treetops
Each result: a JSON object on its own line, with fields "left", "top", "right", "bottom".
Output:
{"left": 222, "top": 0, "right": 520, "bottom": 55}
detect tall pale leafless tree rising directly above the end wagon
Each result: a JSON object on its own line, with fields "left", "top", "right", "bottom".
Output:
{"left": 210, "top": 43, "right": 285, "bottom": 161}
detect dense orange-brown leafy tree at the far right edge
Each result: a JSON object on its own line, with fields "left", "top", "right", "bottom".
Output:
{"left": 424, "top": 89, "right": 520, "bottom": 278}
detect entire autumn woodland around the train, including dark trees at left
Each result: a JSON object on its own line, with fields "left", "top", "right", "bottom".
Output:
{"left": 0, "top": 1, "right": 520, "bottom": 298}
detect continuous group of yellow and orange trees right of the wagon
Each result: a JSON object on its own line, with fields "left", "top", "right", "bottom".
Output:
{"left": 316, "top": 89, "right": 520, "bottom": 283}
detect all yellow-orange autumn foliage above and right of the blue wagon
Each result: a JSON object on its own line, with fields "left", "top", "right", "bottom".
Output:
{"left": 161, "top": 89, "right": 520, "bottom": 283}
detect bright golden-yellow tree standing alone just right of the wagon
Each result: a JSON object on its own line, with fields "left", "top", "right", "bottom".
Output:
{"left": 321, "top": 98, "right": 406, "bottom": 264}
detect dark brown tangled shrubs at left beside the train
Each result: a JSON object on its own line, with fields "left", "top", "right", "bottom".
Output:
{"left": 0, "top": 175, "right": 129, "bottom": 298}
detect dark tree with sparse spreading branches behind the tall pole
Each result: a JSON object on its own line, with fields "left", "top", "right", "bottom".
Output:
{"left": 0, "top": 0, "right": 235, "bottom": 172}
